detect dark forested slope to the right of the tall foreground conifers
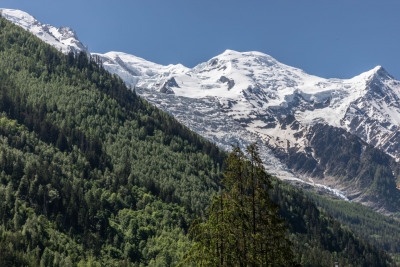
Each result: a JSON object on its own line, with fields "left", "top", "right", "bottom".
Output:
{"left": 271, "top": 179, "right": 392, "bottom": 266}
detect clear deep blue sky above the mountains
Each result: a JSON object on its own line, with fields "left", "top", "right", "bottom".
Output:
{"left": 0, "top": 0, "right": 400, "bottom": 79}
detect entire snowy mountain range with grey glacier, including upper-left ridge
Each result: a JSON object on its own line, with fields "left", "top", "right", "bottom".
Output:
{"left": 1, "top": 9, "right": 400, "bottom": 214}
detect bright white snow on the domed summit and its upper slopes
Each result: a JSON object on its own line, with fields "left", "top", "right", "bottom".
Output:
{"left": 96, "top": 47, "right": 398, "bottom": 136}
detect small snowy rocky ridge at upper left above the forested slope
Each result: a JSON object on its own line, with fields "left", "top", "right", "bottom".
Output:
{"left": 0, "top": 8, "right": 88, "bottom": 53}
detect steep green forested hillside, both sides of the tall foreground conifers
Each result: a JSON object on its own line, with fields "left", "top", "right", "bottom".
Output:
{"left": 0, "top": 18, "right": 391, "bottom": 266}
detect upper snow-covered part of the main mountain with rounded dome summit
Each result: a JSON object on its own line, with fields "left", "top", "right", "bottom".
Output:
{"left": 93, "top": 50, "right": 400, "bottom": 159}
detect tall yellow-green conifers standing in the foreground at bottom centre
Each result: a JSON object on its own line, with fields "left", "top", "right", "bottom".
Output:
{"left": 182, "top": 144, "right": 295, "bottom": 266}
